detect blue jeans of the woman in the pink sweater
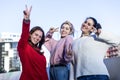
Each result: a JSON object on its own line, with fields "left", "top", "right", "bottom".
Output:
{"left": 50, "top": 66, "right": 69, "bottom": 80}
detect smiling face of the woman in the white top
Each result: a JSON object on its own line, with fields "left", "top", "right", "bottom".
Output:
{"left": 81, "top": 19, "right": 94, "bottom": 35}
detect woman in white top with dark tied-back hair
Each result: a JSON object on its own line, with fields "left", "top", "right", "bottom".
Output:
{"left": 72, "top": 17, "right": 120, "bottom": 80}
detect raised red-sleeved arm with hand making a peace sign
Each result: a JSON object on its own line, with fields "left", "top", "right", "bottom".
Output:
{"left": 17, "top": 6, "right": 32, "bottom": 53}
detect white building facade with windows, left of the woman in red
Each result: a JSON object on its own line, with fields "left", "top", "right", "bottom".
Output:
{"left": 0, "top": 32, "right": 20, "bottom": 72}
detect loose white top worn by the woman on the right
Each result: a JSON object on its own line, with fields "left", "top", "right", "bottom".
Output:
{"left": 73, "top": 30, "right": 120, "bottom": 78}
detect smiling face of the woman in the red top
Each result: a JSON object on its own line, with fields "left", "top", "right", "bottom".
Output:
{"left": 30, "top": 30, "right": 43, "bottom": 45}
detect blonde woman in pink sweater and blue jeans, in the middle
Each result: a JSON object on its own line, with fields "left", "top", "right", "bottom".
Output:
{"left": 45, "top": 21, "right": 74, "bottom": 80}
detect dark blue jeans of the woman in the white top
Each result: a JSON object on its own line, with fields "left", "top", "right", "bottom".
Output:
{"left": 77, "top": 75, "right": 110, "bottom": 80}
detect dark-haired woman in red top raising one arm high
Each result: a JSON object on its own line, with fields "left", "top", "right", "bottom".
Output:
{"left": 17, "top": 7, "right": 48, "bottom": 80}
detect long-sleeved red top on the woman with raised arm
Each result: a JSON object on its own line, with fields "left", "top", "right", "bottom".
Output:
{"left": 17, "top": 20, "right": 48, "bottom": 80}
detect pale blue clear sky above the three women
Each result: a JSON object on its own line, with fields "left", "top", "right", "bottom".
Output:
{"left": 0, "top": 0, "right": 120, "bottom": 35}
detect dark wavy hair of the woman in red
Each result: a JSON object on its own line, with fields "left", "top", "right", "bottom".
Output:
{"left": 29, "top": 26, "right": 45, "bottom": 49}
